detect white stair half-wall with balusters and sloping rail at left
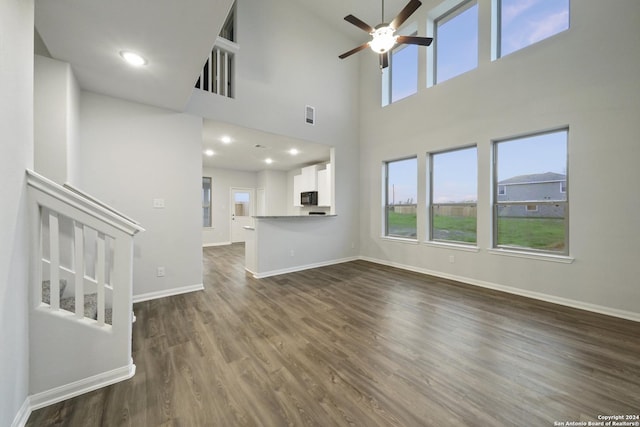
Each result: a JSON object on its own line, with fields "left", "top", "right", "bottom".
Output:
{"left": 27, "top": 171, "right": 144, "bottom": 409}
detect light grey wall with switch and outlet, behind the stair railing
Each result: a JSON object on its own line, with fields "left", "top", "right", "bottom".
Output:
{"left": 78, "top": 91, "right": 202, "bottom": 299}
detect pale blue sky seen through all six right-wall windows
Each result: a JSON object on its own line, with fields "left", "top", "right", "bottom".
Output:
{"left": 389, "top": 0, "right": 569, "bottom": 203}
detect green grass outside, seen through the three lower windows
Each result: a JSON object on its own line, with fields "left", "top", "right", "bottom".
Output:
{"left": 389, "top": 212, "right": 565, "bottom": 251}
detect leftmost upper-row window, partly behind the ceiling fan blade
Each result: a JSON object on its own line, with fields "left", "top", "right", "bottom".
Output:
{"left": 382, "top": 36, "right": 418, "bottom": 107}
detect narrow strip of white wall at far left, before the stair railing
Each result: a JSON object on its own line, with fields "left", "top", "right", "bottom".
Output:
{"left": 0, "top": 0, "right": 33, "bottom": 426}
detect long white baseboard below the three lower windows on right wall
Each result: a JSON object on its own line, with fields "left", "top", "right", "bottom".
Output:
{"left": 359, "top": 256, "right": 640, "bottom": 322}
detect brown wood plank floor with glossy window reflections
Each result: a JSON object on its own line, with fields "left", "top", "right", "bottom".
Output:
{"left": 28, "top": 244, "right": 640, "bottom": 427}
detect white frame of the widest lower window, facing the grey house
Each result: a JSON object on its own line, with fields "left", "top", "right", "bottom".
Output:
{"left": 491, "top": 126, "right": 570, "bottom": 257}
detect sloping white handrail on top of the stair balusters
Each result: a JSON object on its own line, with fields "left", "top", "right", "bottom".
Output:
{"left": 27, "top": 169, "right": 145, "bottom": 236}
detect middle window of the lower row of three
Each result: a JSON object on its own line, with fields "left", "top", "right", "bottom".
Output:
{"left": 430, "top": 147, "right": 478, "bottom": 244}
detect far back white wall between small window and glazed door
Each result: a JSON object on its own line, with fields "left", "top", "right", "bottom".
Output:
{"left": 200, "top": 168, "right": 258, "bottom": 246}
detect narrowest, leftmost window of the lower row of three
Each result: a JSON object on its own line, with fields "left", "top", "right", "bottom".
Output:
{"left": 384, "top": 157, "right": 418, "bottom": 239}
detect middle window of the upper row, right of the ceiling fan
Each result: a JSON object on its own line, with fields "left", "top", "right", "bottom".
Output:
{"left": 434, "top": 1, "right": 478, "bottom": 83}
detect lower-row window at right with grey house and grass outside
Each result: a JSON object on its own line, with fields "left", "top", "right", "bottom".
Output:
{"left": 493, "top": 129, "right": 569, "bottom": 254}
